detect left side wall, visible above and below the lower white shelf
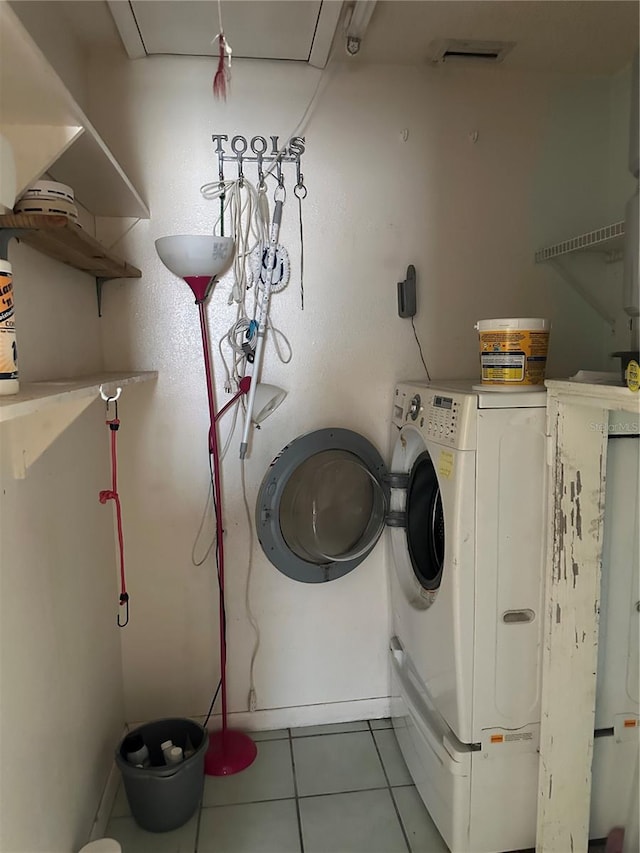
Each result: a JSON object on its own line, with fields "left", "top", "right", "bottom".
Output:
{"left": 0, "top": 241, "right": 124, "bottom": 853}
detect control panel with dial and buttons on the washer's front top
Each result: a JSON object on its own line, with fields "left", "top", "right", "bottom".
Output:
{"left": 392, "top": 383, "right": 478, "bottom": 449}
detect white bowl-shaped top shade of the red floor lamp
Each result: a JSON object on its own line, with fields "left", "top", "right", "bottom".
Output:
{"left": 156, "top": 234, "right": 234, "bottom": 278}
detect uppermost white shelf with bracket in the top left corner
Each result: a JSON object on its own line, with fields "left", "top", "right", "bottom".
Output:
{"left": 0, "top": 2, "right": 149, "bottom": 219}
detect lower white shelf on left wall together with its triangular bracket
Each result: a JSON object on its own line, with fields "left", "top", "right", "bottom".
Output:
{"left": 0, "top": 371, "right": 158, "bottom": 479}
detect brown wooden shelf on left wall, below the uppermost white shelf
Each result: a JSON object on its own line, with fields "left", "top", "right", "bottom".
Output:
{"left": 0, "top": 213, "right": 142, "bottom": 279}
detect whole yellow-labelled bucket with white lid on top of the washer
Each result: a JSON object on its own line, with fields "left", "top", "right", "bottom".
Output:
{"left": 474, "top": 317, "right": 551, "bottom": 390}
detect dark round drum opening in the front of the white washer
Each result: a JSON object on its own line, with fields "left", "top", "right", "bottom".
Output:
{"left": 407, "top": 451, "right": 445, "bottom": 590}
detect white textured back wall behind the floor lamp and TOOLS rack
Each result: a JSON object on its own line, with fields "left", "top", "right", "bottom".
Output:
{"left": 85, "top": 51, "right": 624, "bottom": 721}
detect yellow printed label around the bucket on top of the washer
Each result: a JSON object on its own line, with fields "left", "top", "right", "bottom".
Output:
{"left": 480, "top": 329, "right": 549, "bottom": 385}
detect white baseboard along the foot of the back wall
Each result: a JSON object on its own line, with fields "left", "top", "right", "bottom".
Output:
{"left": 194, "top": 696, "right": 390, "bottom": 731}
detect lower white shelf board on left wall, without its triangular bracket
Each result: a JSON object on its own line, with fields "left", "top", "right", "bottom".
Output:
{"left": 0, "top": 370, "right": 158, "bottom": 423}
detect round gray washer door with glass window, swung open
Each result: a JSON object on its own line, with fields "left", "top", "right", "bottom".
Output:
{"left": 256, "top": 429, "right": 389, "bottom": 583}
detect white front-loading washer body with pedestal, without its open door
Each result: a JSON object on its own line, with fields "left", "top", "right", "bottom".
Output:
{"left": 390, "top": 381, "right": 547, "bottom": 853}
